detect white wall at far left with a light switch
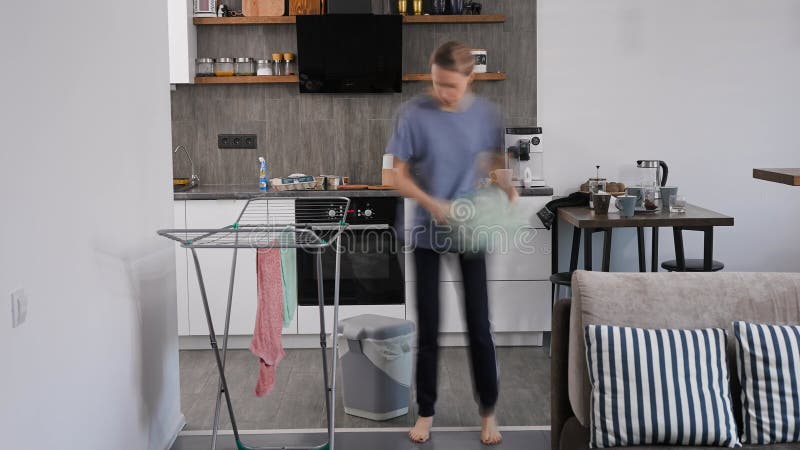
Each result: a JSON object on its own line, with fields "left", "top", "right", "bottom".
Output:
{"left": 0, "top": 0, "right": 182, "bottom": 450}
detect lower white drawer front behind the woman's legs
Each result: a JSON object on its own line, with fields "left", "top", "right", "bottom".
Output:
{"left": 406, "top": 281, "right": 552, "bottom": 333}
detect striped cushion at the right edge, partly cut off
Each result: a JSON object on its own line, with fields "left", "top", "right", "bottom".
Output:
{"left": 733, "top": 322, "right": 800, "bottom": 444}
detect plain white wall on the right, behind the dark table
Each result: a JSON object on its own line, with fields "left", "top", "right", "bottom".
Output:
{"left": 538, "top": 0, "right": 800, "bottom": 271}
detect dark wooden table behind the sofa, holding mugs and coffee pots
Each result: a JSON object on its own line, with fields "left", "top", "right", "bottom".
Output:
{"left": 552, "top": 205, "right": 733, "bottom": 273}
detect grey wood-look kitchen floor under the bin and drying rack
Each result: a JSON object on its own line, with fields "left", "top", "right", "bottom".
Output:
{"left": 180, "top": 347, "right": 550, "bottom": 430}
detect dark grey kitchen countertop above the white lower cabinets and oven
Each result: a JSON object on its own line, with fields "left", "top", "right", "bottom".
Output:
{"left": 174, "top": 184, "right": 553, "bottom": 200}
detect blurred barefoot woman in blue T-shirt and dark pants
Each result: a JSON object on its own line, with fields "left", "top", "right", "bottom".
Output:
{"left": 388, "top": 42, "right": 517, "bottom": 445}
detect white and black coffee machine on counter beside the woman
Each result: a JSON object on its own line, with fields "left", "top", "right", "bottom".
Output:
{"left": 505, "top": 127, "right": 545, "bottom": 187}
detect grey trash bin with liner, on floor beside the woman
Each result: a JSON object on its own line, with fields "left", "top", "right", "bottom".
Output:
{"left": 338, "top": 314, "right": 416, "bottom": 420}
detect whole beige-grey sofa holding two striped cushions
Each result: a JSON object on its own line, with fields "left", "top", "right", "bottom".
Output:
{"left": 550, "top": 271, "right": 800, "bottom": 450}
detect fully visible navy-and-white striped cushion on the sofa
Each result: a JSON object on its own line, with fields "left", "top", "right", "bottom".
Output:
{"left": 585, "top": 325, "right": 739, "bottom": 448}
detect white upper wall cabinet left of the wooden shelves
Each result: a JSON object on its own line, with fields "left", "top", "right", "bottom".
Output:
{"left": 167, "top": 0, "right": 197, "bottom": 84}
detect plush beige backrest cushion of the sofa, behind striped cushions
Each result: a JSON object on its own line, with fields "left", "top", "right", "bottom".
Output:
{"left": 568, "top": 271, "right": 800, "bottom": 426}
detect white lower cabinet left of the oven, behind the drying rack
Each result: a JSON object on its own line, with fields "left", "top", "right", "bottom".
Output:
{"left": 186, "top": 199, "right": 297, "bottom": 335}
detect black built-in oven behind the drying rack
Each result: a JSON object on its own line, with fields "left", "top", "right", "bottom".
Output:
{"left": 295, "top": 196, "right": 405, "bottom": 306}
